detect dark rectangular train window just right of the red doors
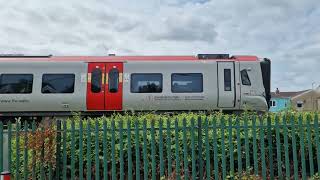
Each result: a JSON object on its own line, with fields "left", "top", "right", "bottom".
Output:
{"left": 131, "top": 73, "right": 162, "bottom": 93}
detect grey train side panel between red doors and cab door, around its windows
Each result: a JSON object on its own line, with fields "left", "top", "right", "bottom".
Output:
{"left": 123, "top": 61, "right": 218, "bottom": 110}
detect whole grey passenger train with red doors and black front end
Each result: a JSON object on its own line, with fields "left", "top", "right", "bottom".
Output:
{"left": 0, "top": 54, "right": 271, "bottom": 117}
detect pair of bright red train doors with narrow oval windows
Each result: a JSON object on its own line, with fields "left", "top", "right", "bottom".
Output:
{"left": 87, "top": 63, "right": 123, "bottom": 111}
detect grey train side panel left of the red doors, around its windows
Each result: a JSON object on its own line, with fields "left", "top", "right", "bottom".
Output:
{"left": 0, "top": 62, "right": 87, "bottom": 112}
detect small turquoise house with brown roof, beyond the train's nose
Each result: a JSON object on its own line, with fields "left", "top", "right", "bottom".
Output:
{"left": 269, "top": 88, "right": 308, "bottom": 112}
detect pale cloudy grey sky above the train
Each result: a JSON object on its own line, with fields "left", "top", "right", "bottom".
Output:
{"left": 0, "top": 0, "right": 320, "bottom": 91}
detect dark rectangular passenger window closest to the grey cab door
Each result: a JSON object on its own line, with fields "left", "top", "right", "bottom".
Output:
{"left": 171, "top": 73, "right": 203, "bottom": 93}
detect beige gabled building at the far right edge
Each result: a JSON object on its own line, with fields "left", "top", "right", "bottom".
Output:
{"left": 291, "top": 86, "right": 320, "bottom": 111}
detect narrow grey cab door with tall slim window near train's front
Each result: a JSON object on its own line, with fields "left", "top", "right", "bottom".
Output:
{"left": 218, "top": 62, "right": 235, "bottom": 108}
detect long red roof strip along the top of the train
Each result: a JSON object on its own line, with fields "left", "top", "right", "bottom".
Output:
{"left": 0, "top": 54, "right": 259, "bottom": 62}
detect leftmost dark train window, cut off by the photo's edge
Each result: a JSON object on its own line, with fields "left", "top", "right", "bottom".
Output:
{"left": 0, "top": 74, "right": 33, "bottom": 94}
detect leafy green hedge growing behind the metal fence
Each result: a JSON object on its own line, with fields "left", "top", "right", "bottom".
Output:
{"left": 8, "top": 112, "right": 317, "bottom": 179}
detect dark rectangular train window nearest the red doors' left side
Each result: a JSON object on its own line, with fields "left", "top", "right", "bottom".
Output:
{"left": 41, "top": 74, "right": 75, "bottom": 93}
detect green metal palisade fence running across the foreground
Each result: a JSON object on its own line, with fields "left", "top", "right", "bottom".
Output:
{"left": 0, "top": 115, "right": 320, "bottom": 179}
